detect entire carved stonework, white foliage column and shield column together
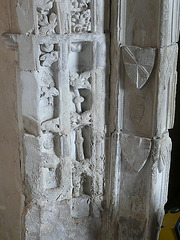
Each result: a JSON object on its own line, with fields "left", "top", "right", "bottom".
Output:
{"left": 3, "top": 0, "right": 180, "bottom": 240}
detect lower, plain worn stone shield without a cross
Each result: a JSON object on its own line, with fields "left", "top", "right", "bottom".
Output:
{"left": 120, "top": 133, "right": 151, "bottom": 173}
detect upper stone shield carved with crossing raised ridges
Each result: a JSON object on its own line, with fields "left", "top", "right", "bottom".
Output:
{"left": 123, "top": 46, "right": 156, "bottom": 89}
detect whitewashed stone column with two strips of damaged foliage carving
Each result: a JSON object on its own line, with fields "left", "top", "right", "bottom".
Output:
{"left": 4, "top": 0, "right": 107, "bottom": 240}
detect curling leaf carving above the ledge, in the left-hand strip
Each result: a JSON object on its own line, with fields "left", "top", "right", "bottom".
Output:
{"left": 37, "top": 0, "right": 57, "bottom": 35}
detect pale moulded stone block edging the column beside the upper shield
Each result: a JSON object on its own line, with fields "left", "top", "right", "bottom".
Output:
{"left": 156, "top": 44, "right": 178, "bottom": 135}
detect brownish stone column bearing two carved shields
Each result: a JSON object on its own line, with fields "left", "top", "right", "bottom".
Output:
{"left": 102, "top": 0, "right": 180, "bottom": 240}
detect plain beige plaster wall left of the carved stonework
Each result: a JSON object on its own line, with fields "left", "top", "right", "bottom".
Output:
{"left": 0, "top": 0, "right": 22, "bottom": 240}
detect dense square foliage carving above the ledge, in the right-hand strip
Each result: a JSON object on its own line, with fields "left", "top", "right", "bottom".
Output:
{"left": 70, "top": 0, "right": 92, "bottom": 33}
